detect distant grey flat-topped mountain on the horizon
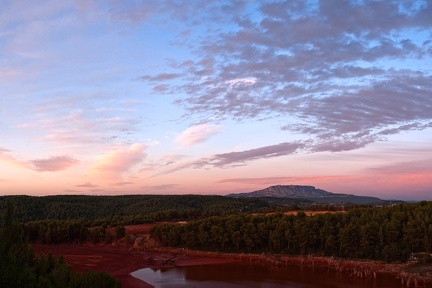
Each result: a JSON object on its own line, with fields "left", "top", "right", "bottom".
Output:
{"left": 227, "top": 185, "right": 403, "bottom": 205}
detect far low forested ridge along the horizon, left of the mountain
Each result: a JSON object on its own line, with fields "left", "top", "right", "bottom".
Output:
{"left": 0, "top": 195, "right": 275, "bottom": 225}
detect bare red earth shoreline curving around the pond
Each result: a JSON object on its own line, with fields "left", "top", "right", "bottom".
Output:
{"left": 32, "top": 244, "right": 432, "bottom": 288}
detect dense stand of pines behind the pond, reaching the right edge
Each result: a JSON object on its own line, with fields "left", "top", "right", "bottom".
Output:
{"left": 150, "top": 202, "right": 432, "bottom": 262}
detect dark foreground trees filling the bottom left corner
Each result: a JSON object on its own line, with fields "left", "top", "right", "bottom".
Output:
{"left": 0, "top": 205, "right": 120, "bottom": 288}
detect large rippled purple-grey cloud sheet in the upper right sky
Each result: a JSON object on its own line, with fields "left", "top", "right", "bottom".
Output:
{"left": 141, "top": 1, "right": 432, "bottom": 152}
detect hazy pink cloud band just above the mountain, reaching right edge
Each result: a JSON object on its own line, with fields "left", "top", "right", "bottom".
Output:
{"left": 216, "top": 159, "right": 432, "bottom": 200}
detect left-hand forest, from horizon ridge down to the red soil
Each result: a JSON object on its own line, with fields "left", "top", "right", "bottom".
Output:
{"left": 0, "top": 195, "right": 278, "bottom": 244}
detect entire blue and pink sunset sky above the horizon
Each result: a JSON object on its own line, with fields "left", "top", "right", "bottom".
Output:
{"left": 0, "top": 0, "right": 432, "bottom": 200}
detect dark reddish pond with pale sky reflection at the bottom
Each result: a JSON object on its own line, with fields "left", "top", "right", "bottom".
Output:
{"left": 131, "top": 262, "right": 400, "bottom": 288}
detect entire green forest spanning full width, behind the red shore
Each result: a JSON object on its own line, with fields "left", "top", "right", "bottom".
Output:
{"left": 0, "top": 195, "right": 432, "bottom": 268}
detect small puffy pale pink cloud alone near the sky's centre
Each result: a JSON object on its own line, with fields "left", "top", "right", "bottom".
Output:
{"left": 175, "top": 124, "right": 222, "bottom": 147}
